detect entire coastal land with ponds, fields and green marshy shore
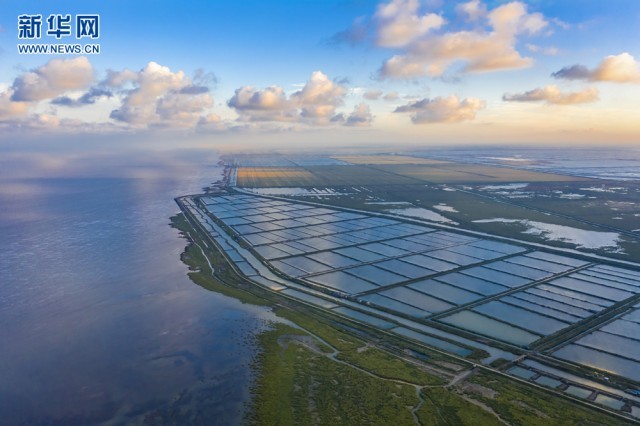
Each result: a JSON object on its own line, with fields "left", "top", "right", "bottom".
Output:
{"left": 174, "top": 150, "right": 640, "bottom": 424}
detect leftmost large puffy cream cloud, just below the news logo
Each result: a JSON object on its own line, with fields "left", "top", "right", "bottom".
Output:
{"left": 11, "top": 56, "right": 94, "bottom": 102}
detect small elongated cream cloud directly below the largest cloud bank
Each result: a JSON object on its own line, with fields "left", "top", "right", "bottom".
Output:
{"left": 394, "top": 95, "right": 486, "bottom": 124}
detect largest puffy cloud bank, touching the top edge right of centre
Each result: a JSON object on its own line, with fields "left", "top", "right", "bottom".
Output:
{"left": 354, "top": 0, "right": 549, "bottom": 79}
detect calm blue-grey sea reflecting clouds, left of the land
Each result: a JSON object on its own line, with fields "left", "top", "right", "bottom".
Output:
{"left": 0, "top": 146, "right": 273, "bottom": 425}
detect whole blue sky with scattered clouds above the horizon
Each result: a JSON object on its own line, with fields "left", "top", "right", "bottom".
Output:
{"left": 0, "top": 0, "right": 640, "bottom": 149}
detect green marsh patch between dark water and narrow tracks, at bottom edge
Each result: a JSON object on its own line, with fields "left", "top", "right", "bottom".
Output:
{"left": 250, "top": 324, "right": 418, "bottom": 425}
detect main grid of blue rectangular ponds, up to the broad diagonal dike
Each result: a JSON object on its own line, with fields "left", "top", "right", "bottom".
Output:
{"left": 194, "top": 195, "right": 640, "bottom": 356}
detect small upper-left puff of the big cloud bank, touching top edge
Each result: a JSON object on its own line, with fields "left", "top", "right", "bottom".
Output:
{"left": 374, "top": 0, "right": 445, "bottom": 47}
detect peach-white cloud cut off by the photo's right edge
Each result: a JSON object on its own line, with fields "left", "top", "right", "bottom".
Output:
{"left": 552, "top": 52, "right": 640, "bottom": 83}
